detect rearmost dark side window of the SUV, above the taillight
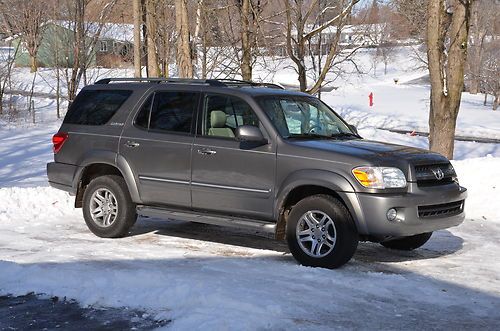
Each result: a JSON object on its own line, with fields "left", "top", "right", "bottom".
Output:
{"left": 64, "top": 90, "right": 132, "bottom": 125}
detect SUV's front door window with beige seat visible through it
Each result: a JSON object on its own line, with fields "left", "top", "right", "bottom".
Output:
{"left": 203, "top": 94, "right": 259, "bottom": 138}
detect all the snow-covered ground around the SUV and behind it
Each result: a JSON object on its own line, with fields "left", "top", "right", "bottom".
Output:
{"left": 0, "top": 48, "right": 500, "bottom": 330}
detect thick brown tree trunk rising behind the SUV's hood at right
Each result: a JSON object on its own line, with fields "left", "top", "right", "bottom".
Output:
{"left": 427, "top": 0, "right": 475, "bottom": 159}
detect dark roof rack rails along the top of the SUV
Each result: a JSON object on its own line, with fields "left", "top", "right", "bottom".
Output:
{"left": 94, "top": 78, "right": 284, "bottom": 90}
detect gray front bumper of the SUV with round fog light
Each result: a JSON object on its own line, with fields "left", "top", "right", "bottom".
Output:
{"left": 344, "top": 184, "right": 467, "bottom": 240}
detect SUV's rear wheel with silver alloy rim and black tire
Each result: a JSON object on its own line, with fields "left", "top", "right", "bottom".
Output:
{"left": 83, "top": 175, "right": 137, "bottom": 238}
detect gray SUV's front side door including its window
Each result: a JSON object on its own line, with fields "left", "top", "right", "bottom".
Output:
{"left": 191, "top": 94, "right": 276, "bottom": 219}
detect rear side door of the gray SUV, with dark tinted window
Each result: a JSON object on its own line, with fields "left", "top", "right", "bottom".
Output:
{"left": 119, "top": 87, "right": 200, "bottom": 207}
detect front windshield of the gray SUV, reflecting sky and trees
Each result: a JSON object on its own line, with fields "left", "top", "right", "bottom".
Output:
{"left": 257, "top": 96, "right": 357, "bottom": 138}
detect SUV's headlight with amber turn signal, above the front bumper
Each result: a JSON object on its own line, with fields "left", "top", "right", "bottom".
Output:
{"left": 352, "top": 167, "right": 406, "bottom": 189}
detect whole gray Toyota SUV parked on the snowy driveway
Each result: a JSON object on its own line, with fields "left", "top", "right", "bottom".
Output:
{"left": 47, "top": 78, "right": 466, "bottom": 268}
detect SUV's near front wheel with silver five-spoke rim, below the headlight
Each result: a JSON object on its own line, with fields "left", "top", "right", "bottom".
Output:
{"left": 286, "top": 195, "right": 358, "bottom": 269}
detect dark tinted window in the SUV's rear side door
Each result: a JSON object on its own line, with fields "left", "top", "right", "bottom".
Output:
{"left": 149, "top": 92, "right": 198, "bottom": 133}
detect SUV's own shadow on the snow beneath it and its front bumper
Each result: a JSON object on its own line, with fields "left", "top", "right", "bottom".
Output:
{"left": 130, "top": 218, "right": 463, "bottom": 263}
